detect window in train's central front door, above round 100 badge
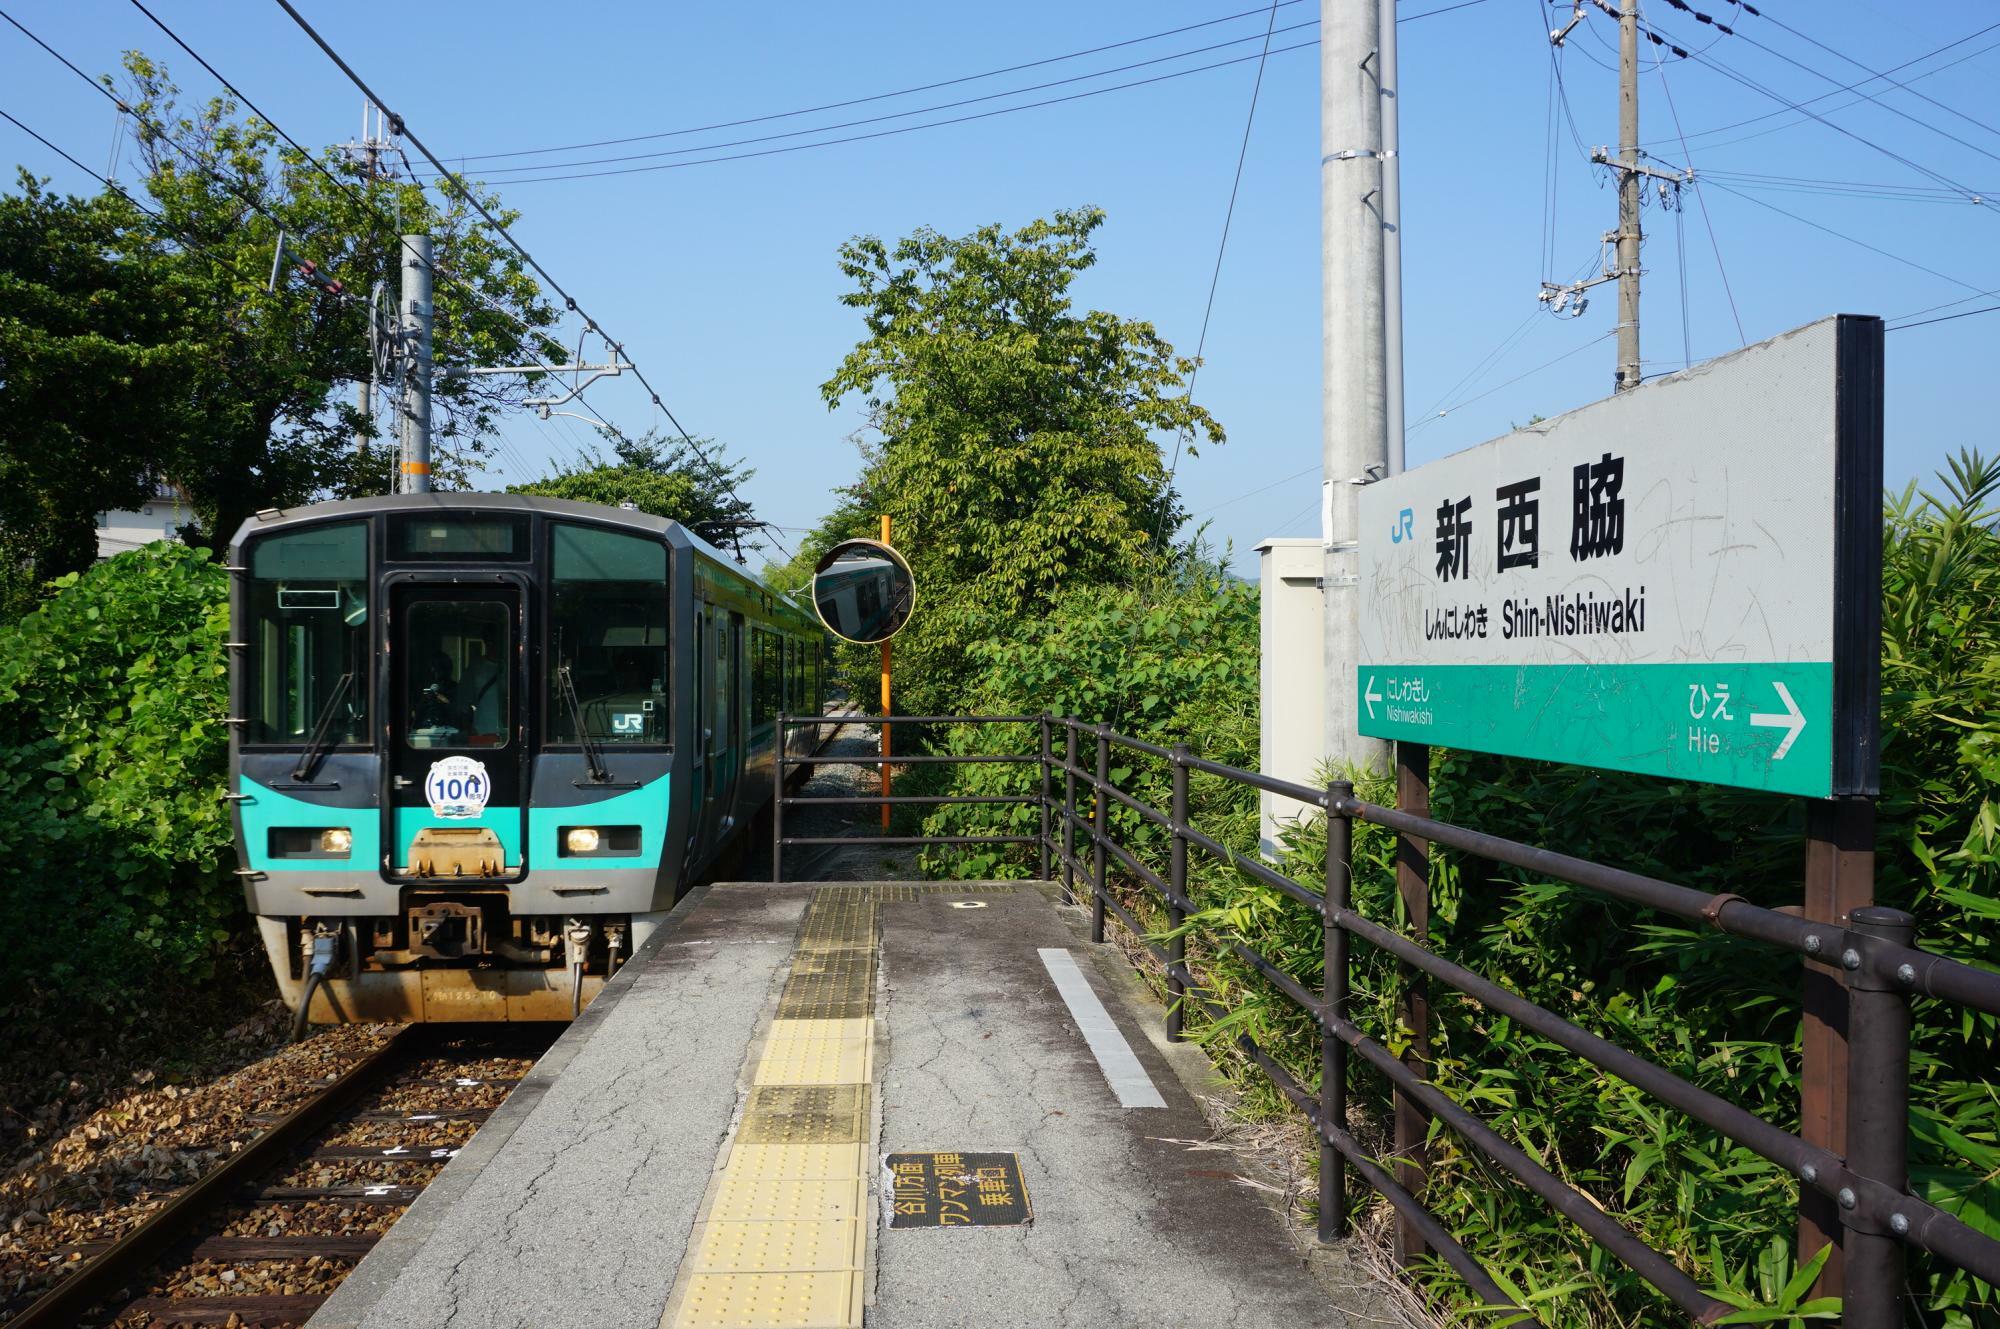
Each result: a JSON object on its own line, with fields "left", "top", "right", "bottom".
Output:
{"left": 402, "top": 600, "right": 514, "bottom": 749}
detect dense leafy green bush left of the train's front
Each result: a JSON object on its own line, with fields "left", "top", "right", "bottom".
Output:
{"left": 0, "top": 542, "right": 242, "bottom": 1007}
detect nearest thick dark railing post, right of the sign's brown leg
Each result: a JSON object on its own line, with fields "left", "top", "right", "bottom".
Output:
{"left": 1838, "top": 905, "right": 1916, "bottom": 1329}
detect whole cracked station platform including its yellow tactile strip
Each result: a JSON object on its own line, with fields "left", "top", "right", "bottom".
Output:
{"left": 312, "top": 883, "right": 1374, "bottom": 1329}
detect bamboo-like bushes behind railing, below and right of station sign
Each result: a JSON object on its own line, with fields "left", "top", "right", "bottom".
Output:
{"left": 1202, "top": 456, "right": 2000, "bottom": 1327}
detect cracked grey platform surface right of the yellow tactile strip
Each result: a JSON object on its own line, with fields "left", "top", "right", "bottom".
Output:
{"left": 868, "top": 889, "right": 1350, "bottom": 1329}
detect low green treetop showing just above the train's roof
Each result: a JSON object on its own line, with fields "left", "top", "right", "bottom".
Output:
{"left": 508, "top": 432, "right": 756, "bottom": 542}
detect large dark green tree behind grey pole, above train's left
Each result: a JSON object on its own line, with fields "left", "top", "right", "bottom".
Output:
{"left": 0, "top": 52, "right": 566, "bottom": 604}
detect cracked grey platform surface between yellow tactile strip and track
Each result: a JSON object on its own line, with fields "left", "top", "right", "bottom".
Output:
{"left": 314, "top": 889, "right": 806, "bottom": 1329}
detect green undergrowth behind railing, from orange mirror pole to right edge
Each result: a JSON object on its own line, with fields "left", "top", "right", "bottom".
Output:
{"left": 928, "top": 454, "right": 2000, "bottom": 1329}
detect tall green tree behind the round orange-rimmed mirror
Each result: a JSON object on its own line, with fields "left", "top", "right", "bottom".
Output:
{"left": 820, "top": 208, "right": 1222, "bottom": 713}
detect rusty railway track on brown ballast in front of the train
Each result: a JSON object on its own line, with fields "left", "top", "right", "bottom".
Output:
{"left": 0, "top": 1025, "right": 560, "bottom": 1329}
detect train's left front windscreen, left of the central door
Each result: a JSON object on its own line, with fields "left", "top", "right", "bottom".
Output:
{"left": 242, "top": 522, "right": 370, "bottom": 745}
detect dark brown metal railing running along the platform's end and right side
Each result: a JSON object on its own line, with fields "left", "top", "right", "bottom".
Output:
{"left": 774, "top": 715, "right": 2000, "bottom": 1329}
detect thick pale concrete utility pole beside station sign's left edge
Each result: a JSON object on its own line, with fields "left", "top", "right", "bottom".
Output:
{"left": 1320, "top": 0, "right": 1388, "bottom": 771}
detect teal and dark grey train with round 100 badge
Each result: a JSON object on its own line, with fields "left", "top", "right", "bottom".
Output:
{"left": 228, "top": 494, "right": 824, "bottom": 1025}
